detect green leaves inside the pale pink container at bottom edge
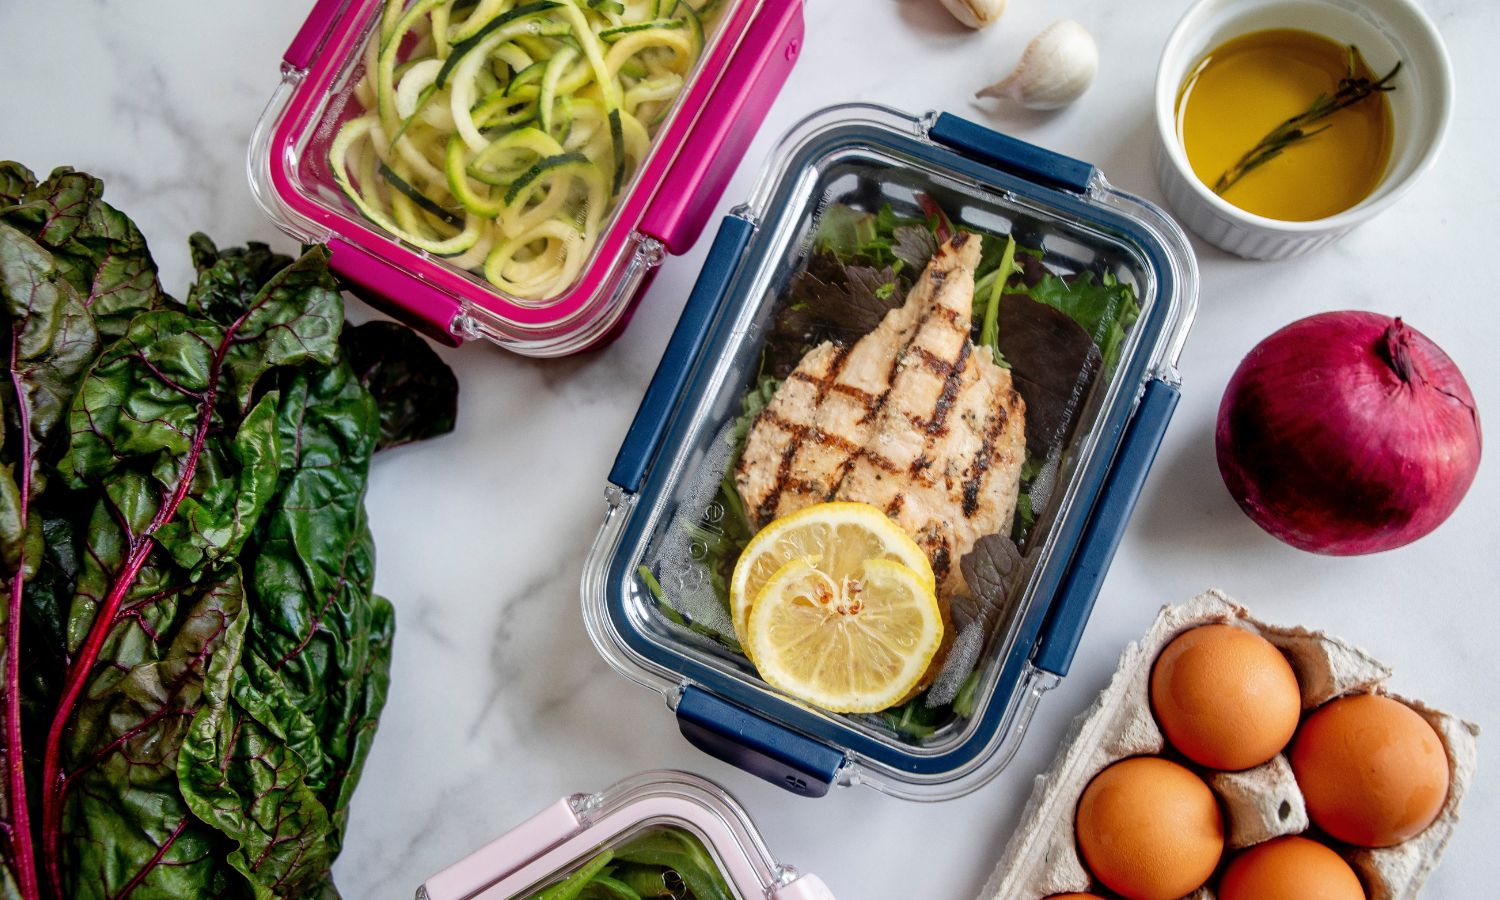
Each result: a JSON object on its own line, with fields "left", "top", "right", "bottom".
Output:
{"left": 527, "top": 827, "right": 735, "bottom": 900}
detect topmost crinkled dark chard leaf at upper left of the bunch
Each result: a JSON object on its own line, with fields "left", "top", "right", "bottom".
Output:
{"left": 0, "top": 168, "right": 171, "bottom": 338}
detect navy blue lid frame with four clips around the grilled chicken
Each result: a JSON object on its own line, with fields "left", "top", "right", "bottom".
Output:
{"left": 591, "top": 108, "right": 1181, "bottom": 795}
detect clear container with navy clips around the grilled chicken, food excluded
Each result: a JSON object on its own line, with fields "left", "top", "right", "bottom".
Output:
{"left": 582, "top": 105, "right": 1199, "bottom": 800}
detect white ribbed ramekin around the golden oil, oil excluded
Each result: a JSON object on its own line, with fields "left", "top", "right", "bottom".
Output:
{"left": 1157, "top": 0, "right": 1454, "bottom": 260}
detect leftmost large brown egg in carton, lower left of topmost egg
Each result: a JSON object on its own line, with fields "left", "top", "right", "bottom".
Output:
{"left": 1076, "top": 756, "right": 1224, "bottom": 900}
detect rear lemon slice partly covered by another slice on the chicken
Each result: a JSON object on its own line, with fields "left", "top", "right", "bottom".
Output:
{"left": 729, "top": 503, "right": 936, "bottom": 662}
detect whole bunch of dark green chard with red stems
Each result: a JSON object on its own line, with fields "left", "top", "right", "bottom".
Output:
{"left": 0, "top": 162, "right": 456, "bottom": 900}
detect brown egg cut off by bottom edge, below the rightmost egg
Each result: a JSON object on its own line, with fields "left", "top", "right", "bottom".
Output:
{"left": 1218, "top": 837, "right": 1365, "bottom": 900}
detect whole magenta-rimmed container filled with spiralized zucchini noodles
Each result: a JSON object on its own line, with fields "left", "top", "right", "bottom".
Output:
{"left": 249, "top": 0, "right": 803, "bottom": 357}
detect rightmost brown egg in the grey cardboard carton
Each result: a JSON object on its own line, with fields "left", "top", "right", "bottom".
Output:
{"left": 1290, "top": 695, "right": 1448, "bottom": 848}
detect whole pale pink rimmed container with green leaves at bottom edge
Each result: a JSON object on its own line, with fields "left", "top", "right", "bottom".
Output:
{"left": 417, "top": 771, "right": 834, "bottom": 900}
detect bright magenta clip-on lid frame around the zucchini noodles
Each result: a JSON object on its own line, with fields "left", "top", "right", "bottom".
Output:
{"left": 258, "top": 0, "right": 803, "bottom": 345}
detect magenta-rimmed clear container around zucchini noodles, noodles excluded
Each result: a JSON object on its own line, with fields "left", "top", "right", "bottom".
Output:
{"left": 249, "top": 0, "right": 803, "bottom": 357}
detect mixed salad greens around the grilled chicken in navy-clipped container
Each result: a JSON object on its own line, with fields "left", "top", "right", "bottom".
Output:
{"left": 669, "top": 197, "right": 1140, "bottom": 738}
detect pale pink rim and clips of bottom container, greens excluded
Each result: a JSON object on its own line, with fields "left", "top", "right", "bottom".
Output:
{"left": 417, "top": 771, "right": 834, "bottom": 900}
